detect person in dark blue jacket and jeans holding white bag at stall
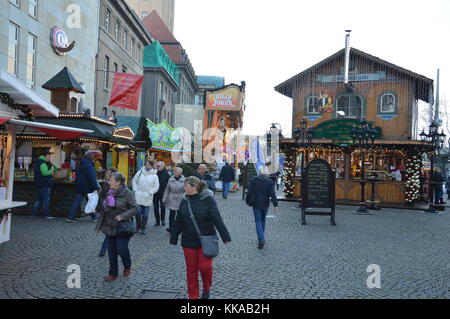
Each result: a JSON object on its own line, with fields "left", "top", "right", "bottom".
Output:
{"left": 67, "top": 151, "right": 100, "bottom": 223}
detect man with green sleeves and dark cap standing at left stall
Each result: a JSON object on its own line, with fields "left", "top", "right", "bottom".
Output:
{"left": 31, "top": 150, "right": 57, "bottom": 219}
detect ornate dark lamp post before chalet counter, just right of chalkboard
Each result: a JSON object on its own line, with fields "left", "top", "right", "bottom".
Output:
{"left": 352, "top": 118, "right": 376, "bottom": 215}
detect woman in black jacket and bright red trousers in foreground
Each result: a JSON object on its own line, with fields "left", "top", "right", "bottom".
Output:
{"left": 170, "top": 176, "right": 231, "bottom": 299}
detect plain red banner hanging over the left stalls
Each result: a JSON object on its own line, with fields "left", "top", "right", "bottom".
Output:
{"left": 109, "top": 72, "right": 144, "bottom": 110}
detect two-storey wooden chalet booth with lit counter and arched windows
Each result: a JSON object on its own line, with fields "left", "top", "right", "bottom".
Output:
{"left": 275, "top": 43, "right": 434, "bottom": 208}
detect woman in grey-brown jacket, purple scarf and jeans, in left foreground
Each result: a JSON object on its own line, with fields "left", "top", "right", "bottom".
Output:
{"left": 96, "top": 173, "right": 137, "bottom": 281}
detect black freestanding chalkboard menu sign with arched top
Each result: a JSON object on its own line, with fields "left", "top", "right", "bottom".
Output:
{"left": 302, "top": 159, "right": 335, "bottom": 225}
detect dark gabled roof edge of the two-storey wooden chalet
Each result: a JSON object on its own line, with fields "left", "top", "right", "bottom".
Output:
{"left": 275, "top": 48, "right": 433, "bottom": 102}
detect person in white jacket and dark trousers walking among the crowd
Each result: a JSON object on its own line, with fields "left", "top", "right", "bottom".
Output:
{"left": 132, "top": 161, "right": 159, "bottom": 235}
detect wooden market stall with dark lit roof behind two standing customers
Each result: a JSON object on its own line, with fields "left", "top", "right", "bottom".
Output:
{"left": 10, "top": 112, "right": 133, "bottom": 216}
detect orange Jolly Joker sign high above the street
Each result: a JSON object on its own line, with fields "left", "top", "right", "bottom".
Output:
{"left": 205, "top": 85, "right": 242, "bottom": 111}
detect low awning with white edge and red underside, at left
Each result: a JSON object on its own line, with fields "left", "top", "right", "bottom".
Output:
{"left": 5, "top": 118, "right": 93, "bottom": 140}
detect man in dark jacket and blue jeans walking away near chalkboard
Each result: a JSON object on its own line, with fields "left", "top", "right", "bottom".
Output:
{"left": 246, "top": 166, "right": 278, "bottom": 249}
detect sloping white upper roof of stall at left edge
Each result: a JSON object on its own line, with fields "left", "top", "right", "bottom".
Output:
{"left": 0, "top": 69, "right": 59, "bottom": 117}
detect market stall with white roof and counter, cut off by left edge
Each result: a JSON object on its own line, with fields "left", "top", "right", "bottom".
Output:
{"left": 0, "top": 68, "right": 92, "bottom": 243}
